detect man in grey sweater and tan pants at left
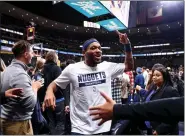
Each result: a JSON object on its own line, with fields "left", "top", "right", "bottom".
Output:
{"left": 0, "top": 40, "right": 42, "bottom": 135}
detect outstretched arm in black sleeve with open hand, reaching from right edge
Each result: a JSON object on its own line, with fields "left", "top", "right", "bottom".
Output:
{"left": 89, "top": 92, "right": 184, "bottom": 125}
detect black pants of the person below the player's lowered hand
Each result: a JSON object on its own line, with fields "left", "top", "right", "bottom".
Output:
{"left": 46, "top": 101, "right": 65, "bottom": 135}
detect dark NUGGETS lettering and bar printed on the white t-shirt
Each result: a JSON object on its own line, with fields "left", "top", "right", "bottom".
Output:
{"left": 78, "top": 72, "right": 106, "bottom": 87}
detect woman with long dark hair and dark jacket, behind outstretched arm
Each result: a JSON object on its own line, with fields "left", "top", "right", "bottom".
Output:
{"left": 136, "top": 65, "right": 179, "bottom": 135}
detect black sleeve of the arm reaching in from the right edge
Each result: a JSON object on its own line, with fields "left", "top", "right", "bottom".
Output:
{"left": 113, "top": 97, "right": 184, "bottom": 123}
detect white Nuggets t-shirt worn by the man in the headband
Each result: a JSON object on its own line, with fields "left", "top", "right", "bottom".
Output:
{"left": 55, "top": 61, "right": 125, "bottom": 134}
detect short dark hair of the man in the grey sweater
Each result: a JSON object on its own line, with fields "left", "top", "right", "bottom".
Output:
{"left": 12, "top": 40, "right": 31, "bottom": 57}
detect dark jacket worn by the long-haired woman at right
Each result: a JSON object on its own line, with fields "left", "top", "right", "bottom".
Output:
{"left": 140, "top": 85, "right": 179, "bottom": 135}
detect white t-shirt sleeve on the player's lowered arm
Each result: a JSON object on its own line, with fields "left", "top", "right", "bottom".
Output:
{"left": 54, "top": 64, "right": 71, "bottom": 89}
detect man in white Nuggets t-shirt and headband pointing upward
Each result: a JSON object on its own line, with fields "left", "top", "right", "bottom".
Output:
{"left": 43, "top": 32, "right": 133, "bottom": 135}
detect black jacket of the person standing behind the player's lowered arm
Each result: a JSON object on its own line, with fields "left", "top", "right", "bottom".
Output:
{"left": 38, "top": 61, "right": 63, "bottom": 102}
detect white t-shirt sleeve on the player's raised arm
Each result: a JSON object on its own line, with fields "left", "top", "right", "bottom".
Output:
{"left": 107, "top": 62, "right": 125, "bottom": 79}
